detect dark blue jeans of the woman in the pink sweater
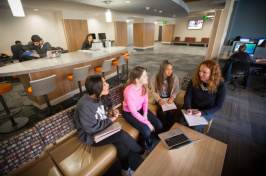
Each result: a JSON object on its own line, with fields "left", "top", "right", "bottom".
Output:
{"left": 122, "top": 108, "right": 163, "bottom": 140}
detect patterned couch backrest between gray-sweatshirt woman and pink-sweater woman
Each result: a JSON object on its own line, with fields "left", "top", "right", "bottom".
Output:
{"left": 109, "top": 84, "right": 125, "bottom": 107}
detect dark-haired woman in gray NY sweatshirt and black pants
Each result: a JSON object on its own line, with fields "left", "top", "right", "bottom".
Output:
{"left": 74, "top": 75, "right": 146, "bottom": 176}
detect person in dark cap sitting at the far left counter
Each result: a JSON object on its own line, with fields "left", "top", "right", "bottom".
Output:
{"left": 22, "top": 35, "right": 52, "bottom": 58}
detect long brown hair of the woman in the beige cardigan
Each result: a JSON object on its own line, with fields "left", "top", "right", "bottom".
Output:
{"left": 156, "top": 60, "right": 174, "bottom": 93}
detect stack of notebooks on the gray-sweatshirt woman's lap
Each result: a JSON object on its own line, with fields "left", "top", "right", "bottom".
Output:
{"left": 93, "top": 122, "right": 121, "bottom": 143}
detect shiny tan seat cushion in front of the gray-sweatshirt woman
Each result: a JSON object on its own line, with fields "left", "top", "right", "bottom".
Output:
{"left": 49, "top": 135, "right": 117, "bottom": 176}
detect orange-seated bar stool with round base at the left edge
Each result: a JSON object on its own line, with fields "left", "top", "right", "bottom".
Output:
{"left": 0, "top": 83, "right": 29, "bottom": 133}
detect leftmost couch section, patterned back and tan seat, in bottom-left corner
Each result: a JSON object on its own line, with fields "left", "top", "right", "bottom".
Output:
{"left": 0, "top": 127, "right": 61, "bottom": 176}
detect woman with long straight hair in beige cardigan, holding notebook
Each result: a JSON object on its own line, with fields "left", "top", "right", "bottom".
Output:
{"left": 150, "top": 60, "right": 179, "bottom": 131}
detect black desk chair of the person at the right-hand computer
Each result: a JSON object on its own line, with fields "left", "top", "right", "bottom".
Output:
{"left": 229, "top": 59, "right": 250, "bottom": 91}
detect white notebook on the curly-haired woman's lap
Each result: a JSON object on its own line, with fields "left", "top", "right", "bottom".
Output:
{"left": 181, "top": 109, "right": 208, "bottom": 126}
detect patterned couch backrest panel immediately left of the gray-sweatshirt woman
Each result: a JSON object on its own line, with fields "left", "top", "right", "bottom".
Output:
{"left": 35, "top": 106, "right": 76, "bottom": 147}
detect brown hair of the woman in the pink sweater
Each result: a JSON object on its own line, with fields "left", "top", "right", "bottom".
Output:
{"left": 126, "top": 66, "right": 148, "bottom": 96}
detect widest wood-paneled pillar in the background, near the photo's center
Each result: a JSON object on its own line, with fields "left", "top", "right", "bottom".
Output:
{"left": 133, "top": 23, "right": 155, "bottom": 47}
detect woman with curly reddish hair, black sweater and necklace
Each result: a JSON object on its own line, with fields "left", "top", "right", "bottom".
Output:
{"left": 179, "top": 60, "right": 226, "bottom": 132}
